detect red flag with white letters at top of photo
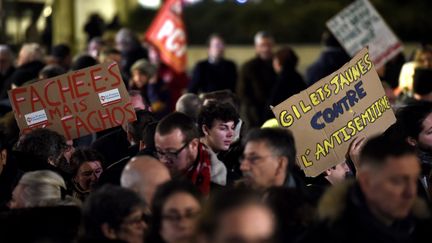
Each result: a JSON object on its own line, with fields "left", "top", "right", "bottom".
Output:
{"left": 145, "top": 0, "right": 186, "bottom": 73}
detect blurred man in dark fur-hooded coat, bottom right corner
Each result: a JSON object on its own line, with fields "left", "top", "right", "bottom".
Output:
{"left": 300, "top": 136, "right": 431, "bottom": 243}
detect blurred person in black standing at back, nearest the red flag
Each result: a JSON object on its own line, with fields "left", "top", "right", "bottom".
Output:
{"left": 189, "top": 34, "right": 237, "bottom": 93}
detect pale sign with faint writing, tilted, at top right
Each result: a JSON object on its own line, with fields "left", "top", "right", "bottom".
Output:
{"left": 326, "top": 0, "right": 403, "bottom": 68}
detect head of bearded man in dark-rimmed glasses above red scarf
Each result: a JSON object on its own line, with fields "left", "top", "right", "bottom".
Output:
{"left": 155, "top": 112, "right": 199, "bottom": 176}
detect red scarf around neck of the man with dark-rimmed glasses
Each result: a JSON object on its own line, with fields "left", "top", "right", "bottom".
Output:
{"left": 187, "top": 143, "right": 211, "bottom": 196}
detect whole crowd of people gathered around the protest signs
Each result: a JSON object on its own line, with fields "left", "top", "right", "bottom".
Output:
{"left": 0, "top": 22, "right": 432, "bottom": 243}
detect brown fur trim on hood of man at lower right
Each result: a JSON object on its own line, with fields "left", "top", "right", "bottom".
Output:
{"left": 317, "top": 180, "right": 431, "bottom": 222}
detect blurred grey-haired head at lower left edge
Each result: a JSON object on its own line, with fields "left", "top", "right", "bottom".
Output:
{"left": 9, "top": 170, "right": 66, "bottom": 208}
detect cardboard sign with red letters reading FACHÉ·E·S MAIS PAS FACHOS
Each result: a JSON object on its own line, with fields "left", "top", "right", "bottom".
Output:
{"left": 8, "top": 63, "right": 136, "bottom": 139}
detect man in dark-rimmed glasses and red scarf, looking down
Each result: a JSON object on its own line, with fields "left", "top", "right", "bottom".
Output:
{"left": 155, "top": 112, "right": 227, "bottom": 195}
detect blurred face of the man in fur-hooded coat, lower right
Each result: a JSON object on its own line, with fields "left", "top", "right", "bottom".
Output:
{"left": 358, "top": 155, "right": 420, "bottom": 222}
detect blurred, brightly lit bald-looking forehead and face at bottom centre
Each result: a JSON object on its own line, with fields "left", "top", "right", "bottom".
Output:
{"left": 213, "top": 205, "right": 275, "bottom": 243}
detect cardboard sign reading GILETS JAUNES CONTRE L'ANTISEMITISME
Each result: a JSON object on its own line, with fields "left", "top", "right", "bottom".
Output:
{"left": 272, "top": 48, "right": 396, "bottom": 176}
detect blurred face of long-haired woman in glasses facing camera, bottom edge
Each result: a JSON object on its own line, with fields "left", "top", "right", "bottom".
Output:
{"left": 159, "top": 192, "right": 201, "bottom": 243}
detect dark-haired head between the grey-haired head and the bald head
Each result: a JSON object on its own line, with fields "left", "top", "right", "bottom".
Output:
{"left": 70, "top": 149, "right": 103, "bottom": 193}
